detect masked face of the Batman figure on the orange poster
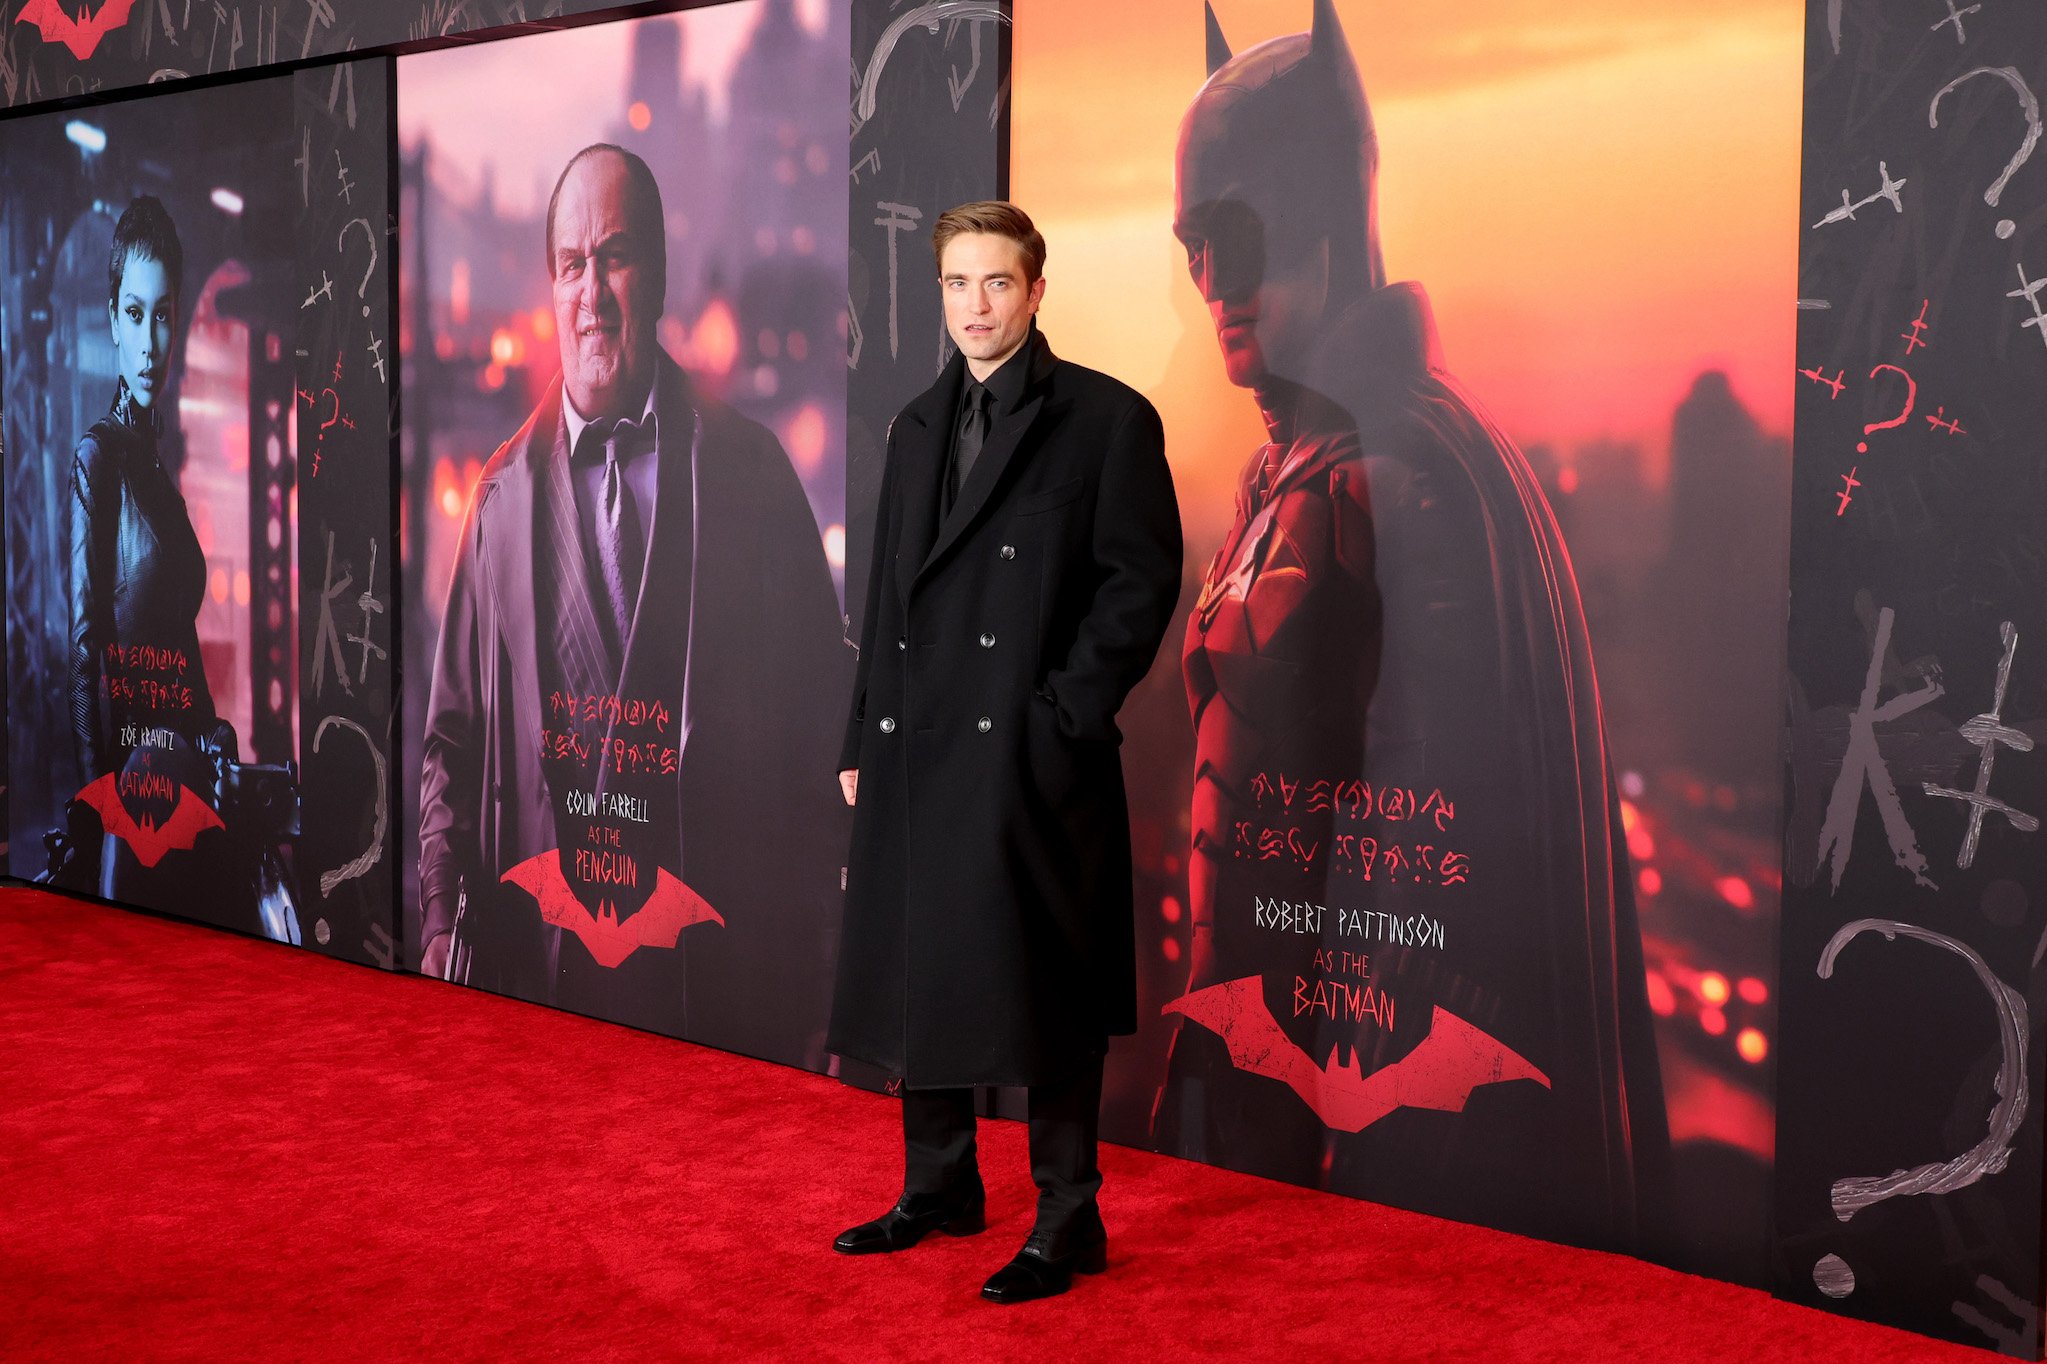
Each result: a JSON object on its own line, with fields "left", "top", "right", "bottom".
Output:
{"left": 1173, "top": 122, "right": 1329, "bottom": 387}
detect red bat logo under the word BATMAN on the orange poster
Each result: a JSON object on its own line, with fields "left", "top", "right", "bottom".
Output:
{"left": 1161, "top": 975, "right": 1550, "bottom": 1133}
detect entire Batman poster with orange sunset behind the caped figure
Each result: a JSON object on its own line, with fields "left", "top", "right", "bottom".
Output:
{"left": 1011, "top": 0, "right": 1799, "bottom": 1282}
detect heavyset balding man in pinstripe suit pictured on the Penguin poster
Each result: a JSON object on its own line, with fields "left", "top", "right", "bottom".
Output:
{"left": 420, "top": 143, "right": 847, "bottom": 1065}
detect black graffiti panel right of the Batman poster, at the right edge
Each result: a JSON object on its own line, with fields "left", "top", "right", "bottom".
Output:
{"left": 1777, "top": 0, "right": 2047, "bottom": 1358}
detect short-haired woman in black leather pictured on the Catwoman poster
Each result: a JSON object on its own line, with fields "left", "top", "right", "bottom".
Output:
{"left": 45, "top": 195, "right": 299, "bottom": 942}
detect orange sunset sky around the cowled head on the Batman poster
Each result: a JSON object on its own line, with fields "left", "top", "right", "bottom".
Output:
{"left": 1011, "top": 0, "right": 1803, "bottom": 532}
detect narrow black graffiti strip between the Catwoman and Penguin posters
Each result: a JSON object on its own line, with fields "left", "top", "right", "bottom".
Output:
{"left": 293, "top": 59, "right": 397, "bottom": 967}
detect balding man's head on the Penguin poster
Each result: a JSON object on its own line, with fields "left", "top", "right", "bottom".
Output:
{"left": 549, "top": 154, "right": 661, "bottom": 420}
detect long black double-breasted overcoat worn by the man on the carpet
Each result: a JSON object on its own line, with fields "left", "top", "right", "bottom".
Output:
{"left": 829, "top": 332, "right": 1181, "bottom": 1088}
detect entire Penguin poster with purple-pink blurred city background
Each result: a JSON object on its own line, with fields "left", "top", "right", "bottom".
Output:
{"left": 399, "top": 0, "right": 852, "bottom": 1067}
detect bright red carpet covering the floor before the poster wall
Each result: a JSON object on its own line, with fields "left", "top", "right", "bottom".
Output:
{"left": 0, "top": 891, "right": 1992, "bottom": 1364}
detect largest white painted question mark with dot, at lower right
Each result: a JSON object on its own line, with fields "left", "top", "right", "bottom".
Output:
{"left": 1812, "top": 920, "right": 2027, "bottom": 1298}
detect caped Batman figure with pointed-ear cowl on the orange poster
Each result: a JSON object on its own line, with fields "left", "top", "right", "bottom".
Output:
{"left": 1152, "top": 0, "right": 1668, "bottom": 1249}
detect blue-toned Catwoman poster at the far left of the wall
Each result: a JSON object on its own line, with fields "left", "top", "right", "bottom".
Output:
{"left": 0, "top": 78, "right": 301, "bottom": 942}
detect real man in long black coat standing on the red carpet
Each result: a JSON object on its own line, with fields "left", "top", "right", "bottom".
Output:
{"left": 829, "top": 203, "right": 1181, "bottom": 1303}
